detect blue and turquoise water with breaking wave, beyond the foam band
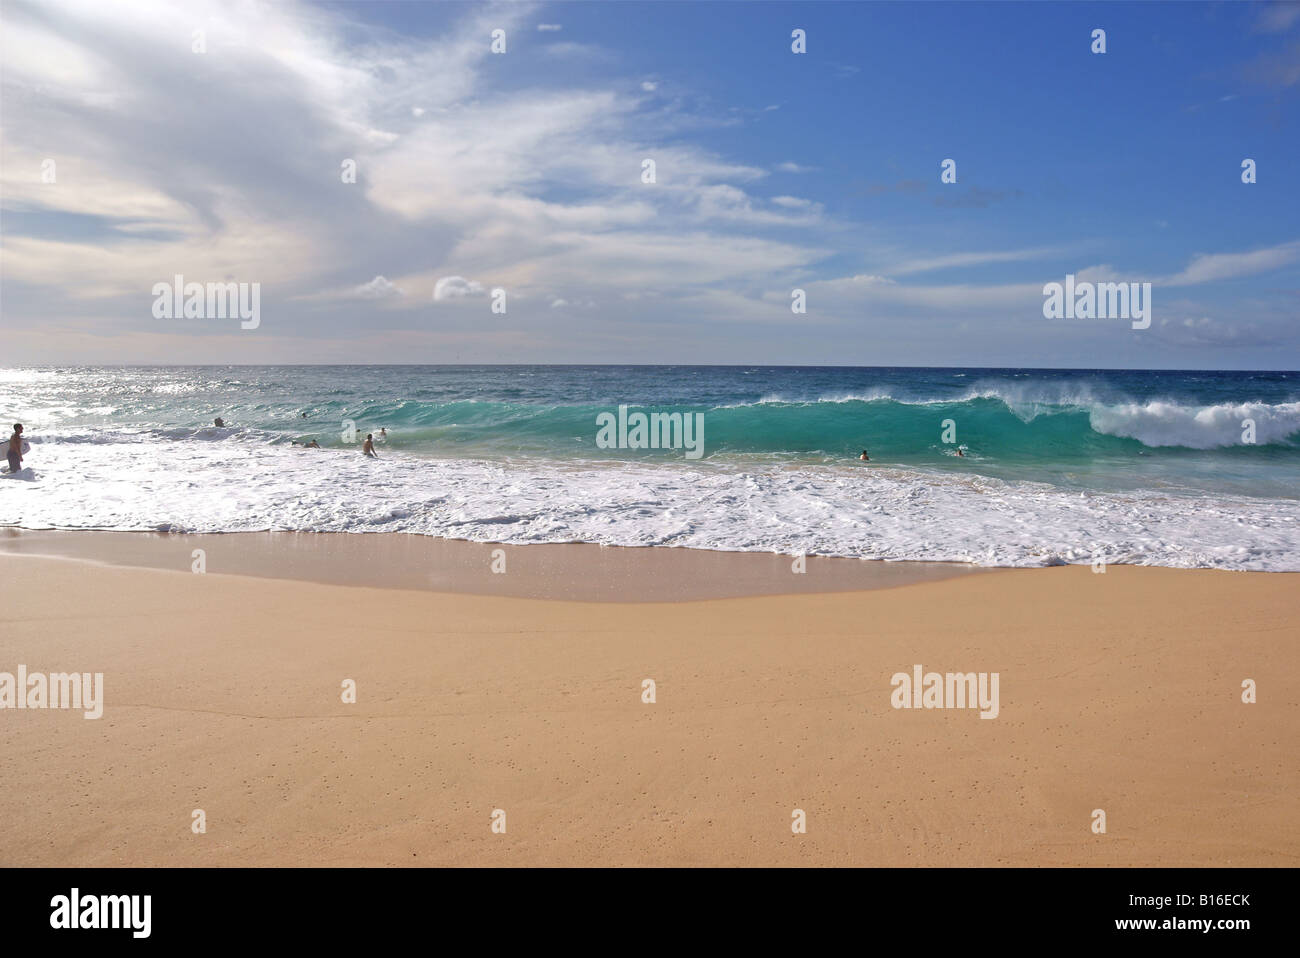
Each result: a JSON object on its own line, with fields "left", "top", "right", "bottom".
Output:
{"left": 12, "top": 367, "right": 1300, "bottom": 497}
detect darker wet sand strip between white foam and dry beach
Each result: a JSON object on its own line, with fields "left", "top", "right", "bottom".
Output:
{"left": 0, "top": 526, "right": 993, "bottom": 602}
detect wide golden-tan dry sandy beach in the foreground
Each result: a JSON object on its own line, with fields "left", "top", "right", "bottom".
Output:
{"left": 0, "top": 533, "right": 1300, "bottom": 866}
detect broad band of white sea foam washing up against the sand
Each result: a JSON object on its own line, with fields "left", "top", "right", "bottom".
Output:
{"left": 0, "top": 431, "right": 1300, "bottom": 571}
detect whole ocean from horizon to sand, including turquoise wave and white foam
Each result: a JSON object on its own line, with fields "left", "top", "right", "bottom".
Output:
{"left": 0, "top": 365, "right": 1300, "bottom": 571}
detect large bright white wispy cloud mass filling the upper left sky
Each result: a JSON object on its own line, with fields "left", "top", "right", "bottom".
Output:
{"left": 0, "top": 0, "right": 828, "bottom": 335}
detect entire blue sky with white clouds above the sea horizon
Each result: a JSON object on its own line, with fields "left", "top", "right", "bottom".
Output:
{"left": 0, "top": 0, "right": 1300, "bottom": 369}
